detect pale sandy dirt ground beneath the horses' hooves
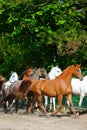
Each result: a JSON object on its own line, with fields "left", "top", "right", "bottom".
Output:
{"left": 0, "top": 108, "right": 87, "bottom": 130}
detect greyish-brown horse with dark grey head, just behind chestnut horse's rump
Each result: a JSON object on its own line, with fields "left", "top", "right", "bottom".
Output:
{"left": 10, "top": 68, "right": 48, "bottom": 112}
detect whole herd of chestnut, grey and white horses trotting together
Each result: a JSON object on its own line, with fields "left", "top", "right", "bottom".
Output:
{"left": 0, "top": 64, "right": 87, "bottom": 117}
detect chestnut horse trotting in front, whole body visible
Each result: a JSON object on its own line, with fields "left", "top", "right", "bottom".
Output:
{"left": 28, "top": 64, "right": 83, "bottom": 116}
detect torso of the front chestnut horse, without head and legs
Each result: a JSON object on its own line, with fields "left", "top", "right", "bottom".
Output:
{"left": 31, "top": 74, "right": 72, "bottom": 97}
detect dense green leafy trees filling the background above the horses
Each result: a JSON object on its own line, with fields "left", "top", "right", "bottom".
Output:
{"left": 0, "top": 0, "right": 87, "bottom": 78}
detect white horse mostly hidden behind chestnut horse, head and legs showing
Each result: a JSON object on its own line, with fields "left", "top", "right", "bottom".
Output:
{"left": 44, "top": 66, "right": 62, "bottom": 111}
